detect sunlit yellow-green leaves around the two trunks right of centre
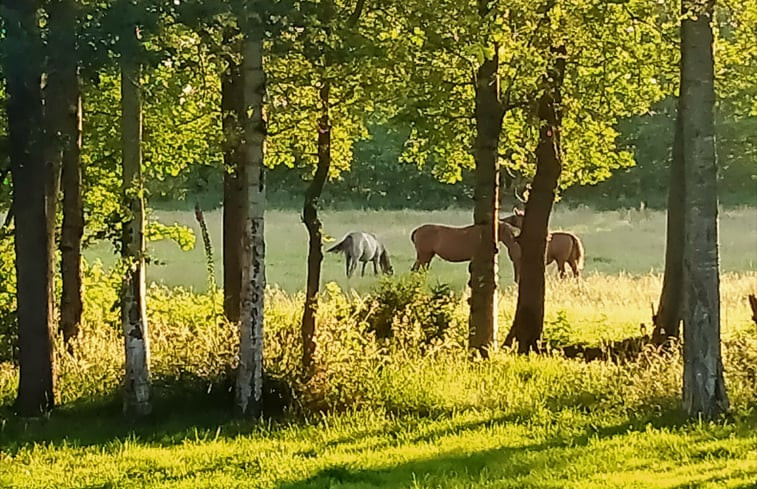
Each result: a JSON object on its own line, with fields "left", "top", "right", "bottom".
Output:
{"left": 376, "top": 0, "right": 676, "bottom": 188}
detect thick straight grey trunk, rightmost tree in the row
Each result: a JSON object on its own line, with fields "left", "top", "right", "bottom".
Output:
{"left": 680, "top": 0, "right": 728, "bottom": 419}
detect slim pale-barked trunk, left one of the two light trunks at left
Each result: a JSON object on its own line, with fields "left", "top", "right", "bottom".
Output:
{"left": 121, "top": 55, "right": 152, "bottom": 416}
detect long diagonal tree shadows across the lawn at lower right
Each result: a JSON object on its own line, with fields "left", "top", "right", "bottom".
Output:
{"left": 276, "top": 412, "right": 757, "bottom": 489}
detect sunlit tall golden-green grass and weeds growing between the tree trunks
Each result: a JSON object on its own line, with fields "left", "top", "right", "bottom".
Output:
{"left": 0, "top": 269, "right": 757, "bottom": 415}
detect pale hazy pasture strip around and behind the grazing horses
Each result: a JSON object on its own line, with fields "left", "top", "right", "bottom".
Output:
{"left": 86, "top": 204, "right": 757, "bottom": 292}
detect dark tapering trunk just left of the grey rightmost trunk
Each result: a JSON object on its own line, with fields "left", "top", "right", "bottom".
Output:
{"left": 652, "top": 101, "right": 686, "bottom": 345}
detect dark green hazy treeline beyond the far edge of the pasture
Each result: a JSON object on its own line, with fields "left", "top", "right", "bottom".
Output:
{"left": 148, "top": 98, "right": 757, "bottom": 210}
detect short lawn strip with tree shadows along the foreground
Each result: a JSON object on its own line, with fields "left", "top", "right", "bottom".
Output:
{"left": 0, "top": 398, "right": 757, "bottom": 489}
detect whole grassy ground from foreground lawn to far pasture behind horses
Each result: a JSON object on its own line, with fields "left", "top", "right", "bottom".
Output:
{"left": 0, "top": 204, "right": 757, "bottom": 489}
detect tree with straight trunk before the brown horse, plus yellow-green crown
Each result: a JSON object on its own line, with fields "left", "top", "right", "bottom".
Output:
{"left": 380, "top": 0, "right": 669, "bottom": 349}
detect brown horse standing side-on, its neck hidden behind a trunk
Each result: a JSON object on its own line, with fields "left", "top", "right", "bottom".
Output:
{"left": 410, "top": 221, "right": 520, "bottom": 282}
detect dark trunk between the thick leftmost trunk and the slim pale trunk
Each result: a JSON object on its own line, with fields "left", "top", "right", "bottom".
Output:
{"left": 45, "top": 0, "right": 84, "bottom": 344}
